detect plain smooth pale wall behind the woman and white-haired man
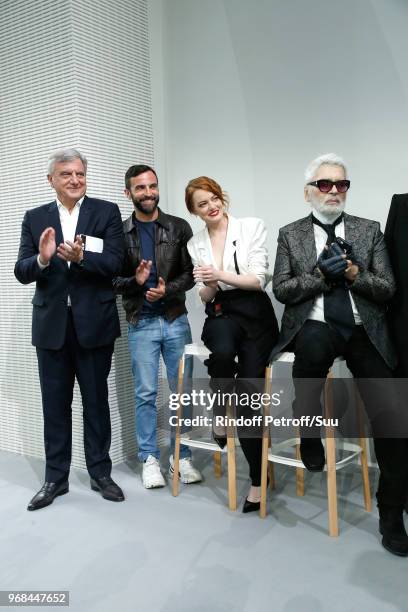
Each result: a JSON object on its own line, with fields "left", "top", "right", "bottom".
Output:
{"left": 150, "top": 0, "right": 408, "bottom": 337}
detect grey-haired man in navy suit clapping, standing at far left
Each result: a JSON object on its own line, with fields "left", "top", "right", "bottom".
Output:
{"left": 14, "top": 149, "right": 124, "bottom": 510}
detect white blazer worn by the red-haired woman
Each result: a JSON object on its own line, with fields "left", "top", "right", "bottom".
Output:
{"left": 187, "top": 215, "right": 271, "bottom": 291}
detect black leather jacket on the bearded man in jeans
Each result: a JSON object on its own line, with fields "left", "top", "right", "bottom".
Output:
{"left": 113, "top": 208, "right": 194, "bottom": 325}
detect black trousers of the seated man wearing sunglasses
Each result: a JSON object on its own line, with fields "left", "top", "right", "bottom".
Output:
{"left": 293, "top": 321, "right": 408, "bottom": 507}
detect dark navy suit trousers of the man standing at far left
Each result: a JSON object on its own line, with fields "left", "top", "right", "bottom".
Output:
{"left": 37, "top": 309, "right": 113, "bottom": 482}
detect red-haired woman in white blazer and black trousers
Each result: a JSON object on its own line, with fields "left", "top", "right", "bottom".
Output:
{"left": 185, "top": 176, "right": 278, "bottom": 512}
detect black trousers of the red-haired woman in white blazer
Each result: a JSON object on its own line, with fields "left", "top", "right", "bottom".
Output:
{"left": 201, "top": 316, "right": 276, "bottom": 486}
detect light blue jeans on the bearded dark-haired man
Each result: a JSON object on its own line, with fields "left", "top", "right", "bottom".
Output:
{"left": 128, "top": 314, "right": 192, "bottom": 461}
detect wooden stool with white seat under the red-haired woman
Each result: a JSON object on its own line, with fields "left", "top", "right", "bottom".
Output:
{"left": 173, "top": 344, "right": 237, "bottom": 510}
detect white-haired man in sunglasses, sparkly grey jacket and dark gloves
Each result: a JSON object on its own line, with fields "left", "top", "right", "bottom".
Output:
{"left": 273, "top": 154, "right": 408, "bottom": 556}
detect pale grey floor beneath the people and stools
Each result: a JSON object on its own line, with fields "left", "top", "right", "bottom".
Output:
{"left": 0, "top": 451, "right": 408, "bottom": 612}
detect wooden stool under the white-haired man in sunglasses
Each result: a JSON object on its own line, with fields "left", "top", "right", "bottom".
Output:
{"left": 260, "top": 352, "right": 371, "bottom": 537}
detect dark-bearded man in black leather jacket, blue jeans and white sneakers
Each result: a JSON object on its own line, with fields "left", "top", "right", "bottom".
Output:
{"left": 113, "top": 165, "right": 201, "bottom": 489}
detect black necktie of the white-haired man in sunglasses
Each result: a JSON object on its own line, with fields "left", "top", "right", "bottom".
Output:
{"left": 312, "top": 215, "right": 355, "bottom": 341}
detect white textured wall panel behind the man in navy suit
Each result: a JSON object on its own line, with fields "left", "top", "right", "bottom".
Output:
{"left": 0, "top": 0, "right": 153, "bottom": 466}
